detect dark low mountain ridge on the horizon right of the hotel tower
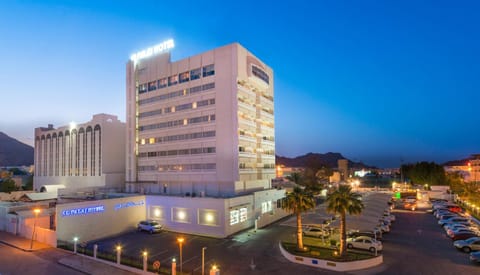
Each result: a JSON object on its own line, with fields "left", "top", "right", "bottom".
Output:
{"left": 275, "top": 152, "right": 375, "bottom": 168}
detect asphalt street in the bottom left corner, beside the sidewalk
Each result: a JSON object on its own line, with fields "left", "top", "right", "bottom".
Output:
{"left": 0, "top": 244, "right": 83, "bottom": 275}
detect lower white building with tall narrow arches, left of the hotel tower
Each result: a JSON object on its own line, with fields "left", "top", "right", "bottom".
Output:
{"left": 34, "top": 114, "right": 125, "bottom": 192}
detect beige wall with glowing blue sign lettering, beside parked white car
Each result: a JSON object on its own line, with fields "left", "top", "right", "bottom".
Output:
{"left": 56, "top": 196, "right": 146, "bottom": 242}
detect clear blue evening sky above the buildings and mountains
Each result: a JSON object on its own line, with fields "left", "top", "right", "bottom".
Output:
{"left": 0, "top": 0, "right": 480, "bottom": 167}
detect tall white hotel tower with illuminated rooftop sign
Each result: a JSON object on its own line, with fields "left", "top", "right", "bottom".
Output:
{"left": 126, "top": 41, "right": 275, "bottom": 197}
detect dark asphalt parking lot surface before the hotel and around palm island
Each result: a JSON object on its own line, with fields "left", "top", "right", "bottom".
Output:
{"left": 80, "top": 193, "right": 480, "bottom": 274}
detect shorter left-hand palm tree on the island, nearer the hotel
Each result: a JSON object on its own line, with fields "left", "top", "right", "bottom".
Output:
{"left": 282, "top": 186, "right": 315, "bottom": 251}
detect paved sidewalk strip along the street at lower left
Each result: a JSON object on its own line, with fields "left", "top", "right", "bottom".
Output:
{"left": 0, "top": 231, "right": 147, "bottom": 275}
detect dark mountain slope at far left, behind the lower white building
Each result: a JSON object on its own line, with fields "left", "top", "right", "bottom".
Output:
{"left": 0, "top": 132, "right": 33, "bottom": 166}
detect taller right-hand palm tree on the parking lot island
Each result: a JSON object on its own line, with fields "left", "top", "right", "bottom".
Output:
{"left": 327, "top": 185, "right": 365, "bottom": 256}
